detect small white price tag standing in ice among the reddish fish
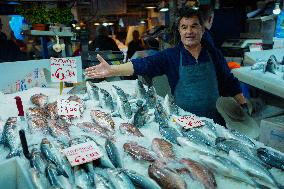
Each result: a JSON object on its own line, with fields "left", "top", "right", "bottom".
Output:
{"left": 57, "top": 99, "right": 81, "bottom": 117}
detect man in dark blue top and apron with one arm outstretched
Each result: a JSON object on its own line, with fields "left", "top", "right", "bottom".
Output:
{"left": 86, "top": 7, "right": 247, "bottom": 125}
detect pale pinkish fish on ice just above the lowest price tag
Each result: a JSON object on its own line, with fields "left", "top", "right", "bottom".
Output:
{"left": 77, "top": 122, "right": 114, "bottom": 138}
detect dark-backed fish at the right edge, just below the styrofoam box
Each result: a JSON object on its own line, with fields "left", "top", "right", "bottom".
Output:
{"left": 257, "top": 148, "right": 284, "bottom": 171}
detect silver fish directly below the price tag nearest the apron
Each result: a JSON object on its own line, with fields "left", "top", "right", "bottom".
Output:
{"left": 182, "top": 129, "right": 215, "bottom": 146}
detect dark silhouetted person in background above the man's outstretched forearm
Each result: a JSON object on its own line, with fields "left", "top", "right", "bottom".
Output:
{"left": 126, "top": 30, "right": 144, "bottom": 60}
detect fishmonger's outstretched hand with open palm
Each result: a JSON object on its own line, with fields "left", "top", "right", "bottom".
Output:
{"left": 86, "top": 54, "right": 113, "bottom": 78}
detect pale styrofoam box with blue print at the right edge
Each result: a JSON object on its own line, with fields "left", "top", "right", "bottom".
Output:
{"left": 259, "top": 115, "right": 284, "bottom": 152}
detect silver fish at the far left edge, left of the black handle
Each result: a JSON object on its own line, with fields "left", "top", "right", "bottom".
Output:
{"left": 1, "top": 117, "right": 20, "bottom": 159}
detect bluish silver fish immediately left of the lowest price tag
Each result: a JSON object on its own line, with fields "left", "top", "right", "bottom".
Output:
{"left": 40, "top": 138, "right": 69, "bottom": 178}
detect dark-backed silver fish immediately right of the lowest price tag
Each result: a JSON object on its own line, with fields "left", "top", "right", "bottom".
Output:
{"left": 105, "top": 139, "right": 122, "bottom": 168}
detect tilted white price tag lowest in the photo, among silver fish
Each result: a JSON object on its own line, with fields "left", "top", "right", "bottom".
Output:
{"left": 63, "top": 141, "right": 103, "bottom": 167}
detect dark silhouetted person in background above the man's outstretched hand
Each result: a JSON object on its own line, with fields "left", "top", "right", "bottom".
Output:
{"left": 89, "top": 25, "right": 120, "bottom": 51}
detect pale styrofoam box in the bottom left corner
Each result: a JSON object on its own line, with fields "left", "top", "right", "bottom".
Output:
{"left": 0, "top": 158, "right": 35, "bottom": 189}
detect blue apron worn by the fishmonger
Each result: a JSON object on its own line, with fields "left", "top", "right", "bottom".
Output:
{"left": 174, "top": 52, "right": 222, "bottom": 123}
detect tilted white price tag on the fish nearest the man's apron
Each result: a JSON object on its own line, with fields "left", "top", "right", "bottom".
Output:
{"left": 174, "top": 115, "right": 205, "bottom": 129}
